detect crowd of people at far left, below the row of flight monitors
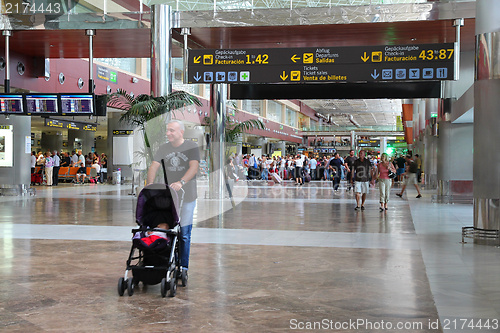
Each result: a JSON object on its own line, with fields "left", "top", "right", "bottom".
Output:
{"left": 31, "top": 150, "right": 108, "bottom": 186}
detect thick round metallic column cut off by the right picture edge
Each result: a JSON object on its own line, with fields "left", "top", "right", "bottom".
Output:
{"left": 473, "top": 0, "right": 500, "bottom": 242}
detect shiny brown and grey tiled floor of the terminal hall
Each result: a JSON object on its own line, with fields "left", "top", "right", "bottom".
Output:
{"left": 0, "top": 182, "right": 500, "bottom": 332}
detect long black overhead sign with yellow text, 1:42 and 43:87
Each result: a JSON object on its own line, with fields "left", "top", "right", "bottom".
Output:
{"left": 187, "top": 43, "right": 455, "bottom": 84}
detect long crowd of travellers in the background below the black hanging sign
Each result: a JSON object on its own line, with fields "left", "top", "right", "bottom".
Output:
{"left": 228, "top": 150, "right": 422, "bottom": 212}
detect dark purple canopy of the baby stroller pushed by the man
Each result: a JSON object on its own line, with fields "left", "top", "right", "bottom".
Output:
{"left": 135, "top": 184, "right": 179, "bottom": 229}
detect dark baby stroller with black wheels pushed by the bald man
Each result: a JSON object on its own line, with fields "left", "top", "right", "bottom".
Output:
{"left": 118, "top": 184, "right": 187, "bottom": 297}
